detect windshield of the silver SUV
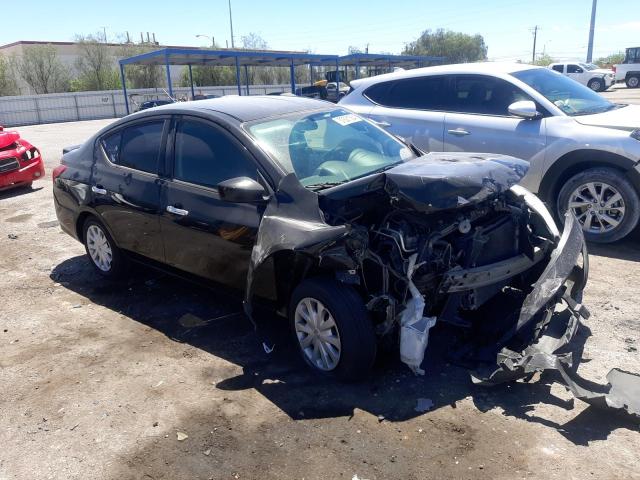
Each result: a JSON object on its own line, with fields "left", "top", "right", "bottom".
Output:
{"left": 511, "top": 68, "right": 618, "bottom": 116}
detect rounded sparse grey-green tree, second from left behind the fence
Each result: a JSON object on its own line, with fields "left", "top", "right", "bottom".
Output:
{"left": 16, "top": 45, "right": 69, "bottom": 93}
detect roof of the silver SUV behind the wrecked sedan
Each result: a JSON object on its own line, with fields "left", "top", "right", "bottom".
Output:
{"left": 351, "top": 62, "right": 544, "bottom": 86}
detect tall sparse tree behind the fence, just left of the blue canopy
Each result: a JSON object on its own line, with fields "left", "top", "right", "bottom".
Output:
{"left": 71, "top": 33, "right": 121, "bottom": 90}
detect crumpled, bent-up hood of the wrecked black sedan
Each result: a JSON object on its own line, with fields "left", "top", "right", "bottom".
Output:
{"left": 384, "top": 153, "right": 529, "bottom": 212}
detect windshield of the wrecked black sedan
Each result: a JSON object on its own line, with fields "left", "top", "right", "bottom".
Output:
{"left": 245, "top": 109, "right": 415, "bottom": 189}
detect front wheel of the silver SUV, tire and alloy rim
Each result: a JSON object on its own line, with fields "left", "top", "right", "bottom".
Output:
{"left": 557, "top": 168, "right": 640, "bottom": 243}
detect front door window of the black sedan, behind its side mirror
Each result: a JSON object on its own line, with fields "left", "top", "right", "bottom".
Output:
{"left": 173, "top": 120, "right": 258, "bottom": 187}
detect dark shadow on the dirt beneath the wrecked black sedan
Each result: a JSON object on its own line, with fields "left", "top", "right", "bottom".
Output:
{"left": 51, "top": 256, "right": 637, "bottom": 445}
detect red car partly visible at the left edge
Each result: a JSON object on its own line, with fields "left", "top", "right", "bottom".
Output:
{"left": 0, "top": 126, "right": 44, "bottom": 190}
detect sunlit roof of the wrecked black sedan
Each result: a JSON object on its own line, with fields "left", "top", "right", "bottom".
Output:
{"left": 148, "top": 95, "right": 337, "bottom": 122}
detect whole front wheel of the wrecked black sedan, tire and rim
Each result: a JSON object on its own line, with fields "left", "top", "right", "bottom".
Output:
{"left": 289, "top": 278, "right": 377, "bottom": 381}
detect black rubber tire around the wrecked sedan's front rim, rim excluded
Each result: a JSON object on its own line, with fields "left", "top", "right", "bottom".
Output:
{"left": 289, "top": 278, "right": 377, "bottom": 381}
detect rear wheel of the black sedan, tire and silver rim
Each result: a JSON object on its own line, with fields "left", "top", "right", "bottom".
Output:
{"left": 82, "top": 217, "right": 126, "bottom": 280}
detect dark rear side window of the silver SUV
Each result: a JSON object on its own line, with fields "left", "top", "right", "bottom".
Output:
{"left": 365, "top": 75, "right": 446, "bottom": 110}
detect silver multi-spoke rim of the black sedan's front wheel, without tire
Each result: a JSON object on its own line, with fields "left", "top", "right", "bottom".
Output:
{"left": 294, "top": 297, "right": 342, "bottom": 372}
